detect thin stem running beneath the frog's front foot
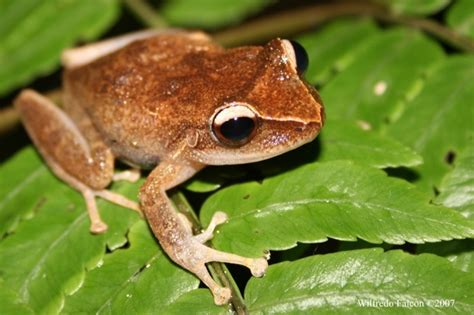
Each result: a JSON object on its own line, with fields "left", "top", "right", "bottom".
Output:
{"left": 171, "top": 191, "right": 247, "bottom": 314}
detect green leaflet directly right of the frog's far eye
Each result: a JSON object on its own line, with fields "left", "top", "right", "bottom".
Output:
{"left": 297, "top": 19, "right": 379, "bottom": 85}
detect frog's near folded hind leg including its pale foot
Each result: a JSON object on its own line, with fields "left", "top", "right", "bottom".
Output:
{"left": 15, "top": 90, "right": 139, "bottom": 233}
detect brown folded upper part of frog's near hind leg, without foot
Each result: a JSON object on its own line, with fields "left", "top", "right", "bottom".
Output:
{"left": 15, "top": 90, "right": 114, "bottom": 190}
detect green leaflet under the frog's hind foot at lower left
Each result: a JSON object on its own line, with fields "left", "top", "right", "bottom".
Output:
{"left": 0, "top": 150, "right": 139, "bottom": 313}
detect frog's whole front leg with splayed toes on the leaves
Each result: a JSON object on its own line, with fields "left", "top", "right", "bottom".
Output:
{"left": 140, "top": 162, "right": 268, "bottom": 305}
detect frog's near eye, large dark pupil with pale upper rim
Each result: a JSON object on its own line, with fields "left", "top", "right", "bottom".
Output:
{"left": 211, "top": 105, "right": 257, "bottom": 147}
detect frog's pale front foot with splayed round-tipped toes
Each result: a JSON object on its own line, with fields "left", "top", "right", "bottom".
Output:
{"left": 177, "top": 211, "right": 268, "bottom": 305}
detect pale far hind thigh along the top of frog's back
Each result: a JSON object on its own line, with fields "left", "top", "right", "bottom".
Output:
{"left": 61, "top": 29, "right": 211, "bottom": 68}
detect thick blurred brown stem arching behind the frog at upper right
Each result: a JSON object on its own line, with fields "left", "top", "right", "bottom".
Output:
{"left": 214, "top": 0, "right": 474, "bottom": 52}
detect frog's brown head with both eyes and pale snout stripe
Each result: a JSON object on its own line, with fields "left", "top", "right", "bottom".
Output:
{"left": 187, "top": 39, "right": 324, "bottom": 165}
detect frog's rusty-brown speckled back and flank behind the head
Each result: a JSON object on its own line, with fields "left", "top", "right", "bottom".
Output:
{"left": 64, "top": 32, "right": 258, "bottom": 167}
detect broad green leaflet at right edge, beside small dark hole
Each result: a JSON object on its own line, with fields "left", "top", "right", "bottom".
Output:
{"left": 387, "top": 55, "right": 474, "bottom": 190}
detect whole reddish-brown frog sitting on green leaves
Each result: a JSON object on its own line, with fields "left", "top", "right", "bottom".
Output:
{"left": 14, "top": 30, "right": 324, "bottom": 305}
